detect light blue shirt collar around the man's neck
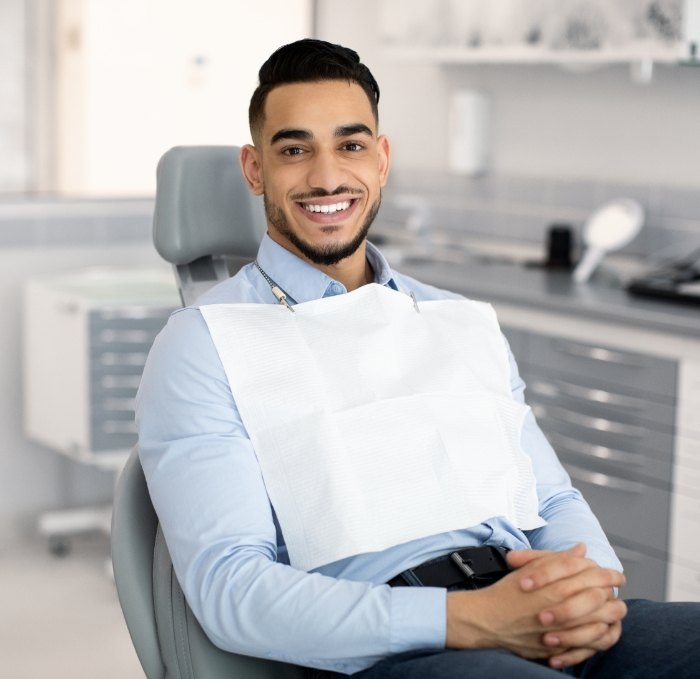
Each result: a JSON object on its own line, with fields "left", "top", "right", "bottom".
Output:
{"left": 257, "top": 234, "right": 398, "bottom": 304}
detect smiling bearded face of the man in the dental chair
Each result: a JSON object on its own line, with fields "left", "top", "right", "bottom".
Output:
{"left": 243, "top": 80, "right": 389, "bottom": 266}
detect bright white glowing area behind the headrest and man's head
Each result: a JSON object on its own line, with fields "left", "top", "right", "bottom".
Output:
{"left": 56, "top": 0, "right": 311, "bottom": 195}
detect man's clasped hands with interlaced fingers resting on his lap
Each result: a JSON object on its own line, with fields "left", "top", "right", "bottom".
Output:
{"left": 446, "top": 544, "right": 627, "bottom": 669}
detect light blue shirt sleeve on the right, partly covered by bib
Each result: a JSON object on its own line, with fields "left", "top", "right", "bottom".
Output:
{"left": 508, "top": 340, "right": 622, "bottom": 571}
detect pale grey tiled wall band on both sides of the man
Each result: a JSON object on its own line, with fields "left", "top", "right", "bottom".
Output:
{"left": 0, "top": 171, "right": 700, "bottom": 260}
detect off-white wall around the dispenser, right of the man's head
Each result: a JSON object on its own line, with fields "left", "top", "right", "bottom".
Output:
{"left": 317, "top": 0, "right": 700, "bottom": 187}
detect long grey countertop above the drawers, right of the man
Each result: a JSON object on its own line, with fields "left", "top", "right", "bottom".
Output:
{"left": 395, "top": 257, "right": 700, "bottom": 339}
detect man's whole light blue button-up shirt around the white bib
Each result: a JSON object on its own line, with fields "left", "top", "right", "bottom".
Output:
{"left": 136, "top": 236, "right": 621, "bottom": 674}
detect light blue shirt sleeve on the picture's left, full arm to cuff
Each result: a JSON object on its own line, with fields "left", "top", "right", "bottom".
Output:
{"left": 136, "top": 309, "right": 446, "bottom": 674}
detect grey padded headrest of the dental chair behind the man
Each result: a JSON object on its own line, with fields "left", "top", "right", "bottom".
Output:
{"left": 153, "top": 146, "right": 266, "bottom": 265}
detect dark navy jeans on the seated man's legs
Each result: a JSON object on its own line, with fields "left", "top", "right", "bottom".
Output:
{"left": 310, "top": 599, "right": 700, "bottom": 679}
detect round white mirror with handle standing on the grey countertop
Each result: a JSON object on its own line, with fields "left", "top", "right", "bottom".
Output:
{"left": 574, "top": 198, "right": 644, "bottom": 283}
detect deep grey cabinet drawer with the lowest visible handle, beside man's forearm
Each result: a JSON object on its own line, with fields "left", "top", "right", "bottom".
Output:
{"left": 562, "top": 459, "right": 670, "bottom": 554}
